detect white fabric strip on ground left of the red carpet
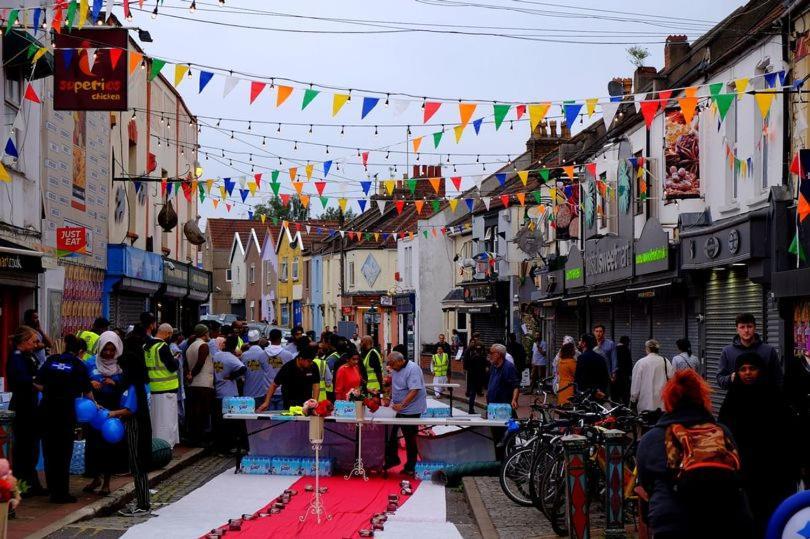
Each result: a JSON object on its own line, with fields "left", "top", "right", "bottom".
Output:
{"left": 123, "top": 468, "right": 300, "bottom": 539}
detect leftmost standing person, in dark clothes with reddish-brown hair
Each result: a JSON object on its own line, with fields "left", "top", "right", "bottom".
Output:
{"left": 6, "top": 326, "right": 48, "bottom": 498}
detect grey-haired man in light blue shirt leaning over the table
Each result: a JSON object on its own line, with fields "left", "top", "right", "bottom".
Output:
{"left": 385, "top": 352, "right": 427, "bottom": 475}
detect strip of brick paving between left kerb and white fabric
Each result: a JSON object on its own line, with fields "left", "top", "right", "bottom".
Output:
{"left": 48, "top": 455, "right": 233, "bottom": 539}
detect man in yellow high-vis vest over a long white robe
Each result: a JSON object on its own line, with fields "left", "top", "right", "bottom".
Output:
{"left": 143, "top": 324, "right": 180, "bottom": 447}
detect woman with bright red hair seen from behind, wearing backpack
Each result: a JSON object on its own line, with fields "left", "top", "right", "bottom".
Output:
{"left": 636, "top": 369, "right": 753, "bottom": 539}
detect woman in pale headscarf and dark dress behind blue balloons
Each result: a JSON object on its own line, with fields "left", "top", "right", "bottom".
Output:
{"left": 84, "top": 331, "right": 125, "bottom": 496}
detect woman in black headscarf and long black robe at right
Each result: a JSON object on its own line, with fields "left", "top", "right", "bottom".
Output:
{"left": 718, "top": 352, "right": 799, "bottom": 537}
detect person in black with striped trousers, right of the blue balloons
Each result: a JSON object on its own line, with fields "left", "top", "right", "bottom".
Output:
{"left": 110, "top": 325, "right": 152, "bottom": 517}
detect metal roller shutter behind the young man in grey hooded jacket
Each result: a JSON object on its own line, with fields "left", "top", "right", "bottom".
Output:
{"left": 705, "top": 269, "right": 764, "bottom": 411}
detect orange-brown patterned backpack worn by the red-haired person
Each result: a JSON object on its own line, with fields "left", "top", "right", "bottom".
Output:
{"left": 664, "top": 423, "right": 740, "bottom": 490}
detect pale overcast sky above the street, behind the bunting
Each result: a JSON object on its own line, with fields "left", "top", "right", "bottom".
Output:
{"left": 131, "top": 0, "right": 744, "bottom": 221}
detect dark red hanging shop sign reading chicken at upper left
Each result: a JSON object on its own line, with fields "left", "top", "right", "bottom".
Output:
{"left": 53, "top": 28, "right": 129, "bottom": 111}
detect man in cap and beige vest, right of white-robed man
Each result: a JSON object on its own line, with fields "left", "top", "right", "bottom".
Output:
{"left": 186, "top": 324, "right": 216, "bottom": 444}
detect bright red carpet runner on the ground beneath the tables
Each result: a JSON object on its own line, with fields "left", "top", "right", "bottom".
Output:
{"left": 205, "top": 474, "right": 419, "bottom": 539}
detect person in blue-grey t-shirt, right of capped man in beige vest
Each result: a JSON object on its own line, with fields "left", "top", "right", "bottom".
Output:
{"left": 213, "top": 334, "right": 247, "bottom": 454}
